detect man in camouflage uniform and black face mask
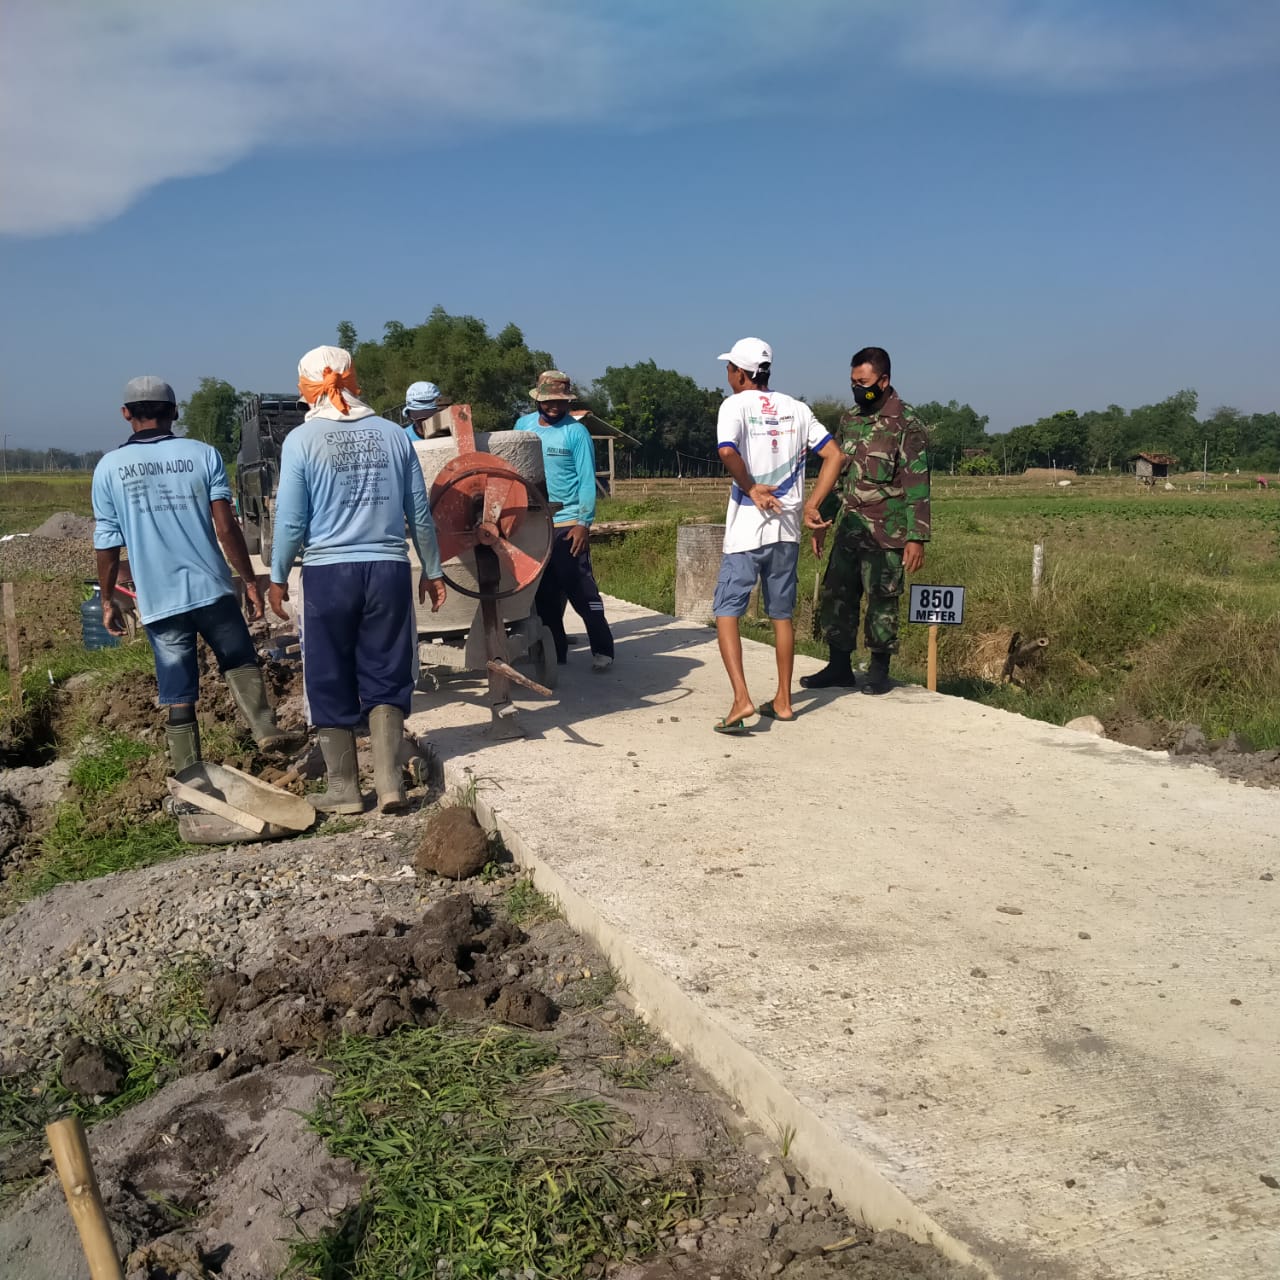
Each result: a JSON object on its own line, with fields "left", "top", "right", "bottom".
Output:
{"left": 800, "top": 347, "right": 929, "bottom": 694}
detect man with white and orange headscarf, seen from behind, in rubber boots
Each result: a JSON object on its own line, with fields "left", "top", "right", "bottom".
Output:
{"left": 268, "top": 347, "right": 444, "bottom": 813}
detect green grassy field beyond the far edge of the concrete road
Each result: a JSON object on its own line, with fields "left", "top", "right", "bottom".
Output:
{"left": 591, "top": 476, "right": 1280, "bottom": 748}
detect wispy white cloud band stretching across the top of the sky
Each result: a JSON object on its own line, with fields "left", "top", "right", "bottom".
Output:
{"left": 0, "top": 0, "right": 1280, "bottom": 234}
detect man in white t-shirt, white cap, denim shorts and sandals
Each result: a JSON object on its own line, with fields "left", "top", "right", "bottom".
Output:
{"left": 714, "top": 338, "right": 844, "bottom": 733}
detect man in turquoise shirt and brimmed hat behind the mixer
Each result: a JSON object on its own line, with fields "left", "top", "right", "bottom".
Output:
{"left": 516, "top": 369, "right": 613, "bottom": 672}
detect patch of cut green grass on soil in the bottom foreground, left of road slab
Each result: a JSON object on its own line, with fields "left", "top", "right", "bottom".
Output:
{"left": 289, "top": 1027, "right": 694, "bottom": 1280}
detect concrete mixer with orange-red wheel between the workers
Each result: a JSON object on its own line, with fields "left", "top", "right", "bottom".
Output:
{"left": 411, "top": 404, "right": 557, "bottom": 737}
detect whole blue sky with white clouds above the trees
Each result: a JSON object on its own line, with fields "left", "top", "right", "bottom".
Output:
{"left": 0, "top": 0, "right": 1280, "bottom": 449}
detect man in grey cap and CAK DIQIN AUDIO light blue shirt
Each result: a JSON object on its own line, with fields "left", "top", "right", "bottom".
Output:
{"left": 93, "top": 375, "right": 292, "bottom": 773}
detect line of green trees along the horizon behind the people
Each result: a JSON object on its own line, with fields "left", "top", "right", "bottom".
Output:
{"left": 6, "top": 307, "right": 1280, "bottom": 475}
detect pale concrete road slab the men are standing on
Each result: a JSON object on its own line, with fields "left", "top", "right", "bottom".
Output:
{"left": 412, "top": 600, "right": 1280, "bottom": 1280}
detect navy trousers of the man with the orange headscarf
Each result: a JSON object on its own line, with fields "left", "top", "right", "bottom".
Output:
{"left": 302, "top": 561, "right": 417, "bottom": 728}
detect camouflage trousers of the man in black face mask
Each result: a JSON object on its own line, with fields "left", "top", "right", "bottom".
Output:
{"left": 814, "top": 520, "right": 904, "bottom": 653}
